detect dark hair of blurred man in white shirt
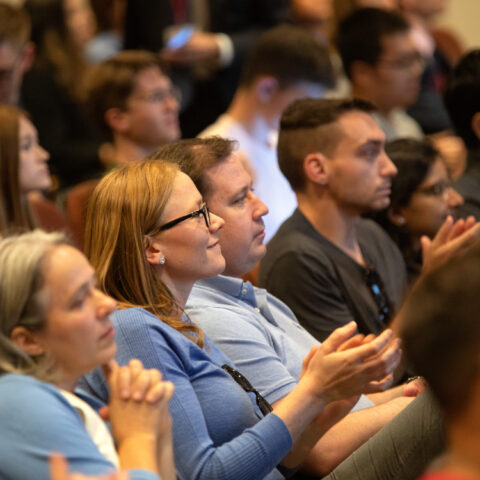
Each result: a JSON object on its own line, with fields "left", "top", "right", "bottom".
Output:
{"left": 240, "top": 25, "right": 335, "bottom": 88}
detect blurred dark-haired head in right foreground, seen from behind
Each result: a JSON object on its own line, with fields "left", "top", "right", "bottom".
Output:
{"left": 398, "top": 244, "right": 480, "bottom": 420}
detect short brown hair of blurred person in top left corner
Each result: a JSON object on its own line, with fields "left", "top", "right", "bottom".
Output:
{"left": 0, "top": 3, "right": 32, "bottom": 50}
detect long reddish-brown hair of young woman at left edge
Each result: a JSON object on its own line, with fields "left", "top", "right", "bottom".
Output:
{"left": 0, "top": 105, "right": 35, "bottom": 235}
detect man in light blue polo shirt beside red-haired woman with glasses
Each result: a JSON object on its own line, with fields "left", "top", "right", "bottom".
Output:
{"left": 155, "top": 137, "right": 443, "bottom": 480}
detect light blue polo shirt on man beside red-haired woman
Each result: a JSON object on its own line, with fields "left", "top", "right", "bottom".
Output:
{"left": 185, "top": 275, "right": 374, "bottom": 410}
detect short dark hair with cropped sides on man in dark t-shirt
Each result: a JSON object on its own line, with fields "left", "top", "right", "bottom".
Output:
{"left": 277, "top": 98, "right": 375, "bottom": 192}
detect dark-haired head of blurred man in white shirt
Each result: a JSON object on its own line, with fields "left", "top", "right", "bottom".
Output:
{"left": 239, "top": 25, "right": 334, "bottom": 128}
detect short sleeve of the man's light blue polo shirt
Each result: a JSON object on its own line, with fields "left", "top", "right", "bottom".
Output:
{"left": 188, "top": 305, "right": 296, "bottom": 403}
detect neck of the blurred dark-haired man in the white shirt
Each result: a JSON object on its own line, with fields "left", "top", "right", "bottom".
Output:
{"left": 227, "top": 88, "right": 278, "bottom": 143}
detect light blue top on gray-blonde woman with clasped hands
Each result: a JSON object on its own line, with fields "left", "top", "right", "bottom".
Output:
{"left": 0, "top": 374, "right": 158, "bottom": 480}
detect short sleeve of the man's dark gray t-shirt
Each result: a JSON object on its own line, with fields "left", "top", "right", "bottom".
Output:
{"left": 265, "top": 251, "right": 353, "bottom": 341}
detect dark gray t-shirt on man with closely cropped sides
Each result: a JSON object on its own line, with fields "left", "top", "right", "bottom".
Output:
{"left": 260, "top": 209, "right": 407, "bottom": 341}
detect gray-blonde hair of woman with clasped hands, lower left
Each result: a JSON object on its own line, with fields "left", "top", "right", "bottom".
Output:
{"left": 0, "top": 230, "right": 70, "bottom": 381}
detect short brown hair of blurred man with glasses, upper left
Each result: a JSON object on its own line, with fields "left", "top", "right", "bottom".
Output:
{"left": 85, "top": 50, "right": 168, "bottom": 138}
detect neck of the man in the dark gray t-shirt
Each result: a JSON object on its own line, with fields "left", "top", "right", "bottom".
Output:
{"left": 297, "top": 187, "right": 365, "bottom": 265}
